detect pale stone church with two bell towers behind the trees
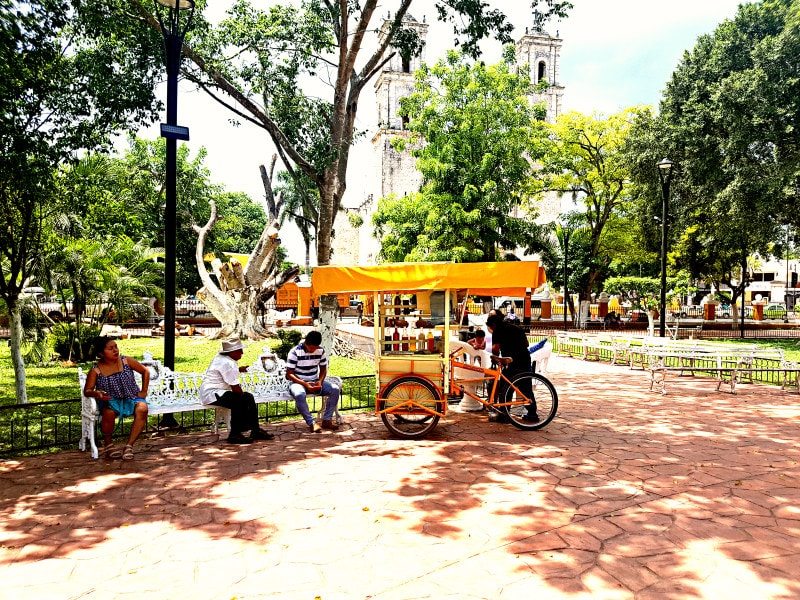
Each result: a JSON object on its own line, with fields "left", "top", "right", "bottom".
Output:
{"left": 332, "top": 15, "right": 564, "bottom": 265}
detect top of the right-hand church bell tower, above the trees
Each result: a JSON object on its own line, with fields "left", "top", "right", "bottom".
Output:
{"left": 516, "top": 24, "right": 564, "bottom": 123}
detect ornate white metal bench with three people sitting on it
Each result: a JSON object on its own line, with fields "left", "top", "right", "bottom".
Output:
{"left": 78, "top": 353, "right": 342, "bottom": 458}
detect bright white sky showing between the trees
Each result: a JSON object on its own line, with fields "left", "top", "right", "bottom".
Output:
{"left": 140, "top": 0, "right": 742, "bottom": 264}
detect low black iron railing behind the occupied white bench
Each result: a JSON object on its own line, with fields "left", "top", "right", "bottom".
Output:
{"left": 0, "top": 375, "right": 376, "bottom": 457}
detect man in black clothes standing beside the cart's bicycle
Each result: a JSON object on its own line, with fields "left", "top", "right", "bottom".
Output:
{"left": 486, "top": 314, "right": 539, "bottom": 423}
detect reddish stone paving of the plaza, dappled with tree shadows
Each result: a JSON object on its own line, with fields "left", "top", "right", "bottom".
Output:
{"left": 0, "top": 358, "right": 800, "bottom": 600}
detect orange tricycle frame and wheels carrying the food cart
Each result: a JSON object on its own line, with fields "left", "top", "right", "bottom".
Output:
{"left": 377, "top": 350, "right": 558, "bottom": 439}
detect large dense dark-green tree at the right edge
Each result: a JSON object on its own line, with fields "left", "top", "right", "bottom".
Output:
{"left": 629, "top": 0, "right": 800, "bottom": 316}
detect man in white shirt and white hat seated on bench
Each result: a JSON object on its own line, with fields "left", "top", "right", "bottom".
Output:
{"left": 200, "top": 339, "right": 275, "bottom": 444}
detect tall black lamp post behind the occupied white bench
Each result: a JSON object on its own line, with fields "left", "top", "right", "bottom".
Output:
{"left": 154, "top": 0, "right": 194, "bottom": 370}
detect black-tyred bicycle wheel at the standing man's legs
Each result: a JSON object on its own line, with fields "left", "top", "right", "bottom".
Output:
{"left": 502, "top": 373, "right": 558, "bottom": 431}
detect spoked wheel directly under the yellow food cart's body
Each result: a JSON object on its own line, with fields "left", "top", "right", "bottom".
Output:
{"left": 378, "top": 375, "right": 444, "bottom": 439}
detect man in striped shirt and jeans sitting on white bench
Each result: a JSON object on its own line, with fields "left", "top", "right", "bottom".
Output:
{"left": 286, "top": 331, "right": 340, "bottom": 433}
